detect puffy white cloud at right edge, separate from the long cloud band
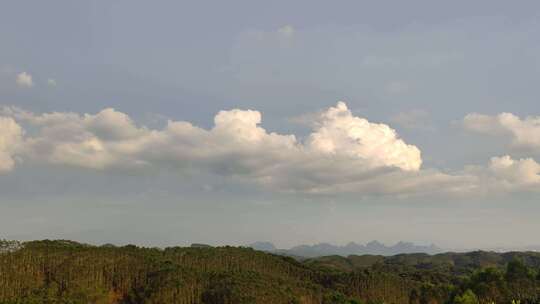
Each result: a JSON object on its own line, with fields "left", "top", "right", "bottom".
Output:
{"left": 463, "top": 113, "right": 540, "bottom": 152}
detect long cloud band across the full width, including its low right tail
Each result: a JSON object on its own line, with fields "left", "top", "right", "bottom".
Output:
{"left": 0, "top": 102, "right": 540, "bottom": 195}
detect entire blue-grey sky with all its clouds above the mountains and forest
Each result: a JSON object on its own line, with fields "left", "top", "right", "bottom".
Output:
{"left": 0, "top": 0, "right": 540, "bottom": 249}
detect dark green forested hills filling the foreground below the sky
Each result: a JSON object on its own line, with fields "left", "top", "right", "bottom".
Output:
{"left": 0, "top": 240, "right": 540, "bottom": 304}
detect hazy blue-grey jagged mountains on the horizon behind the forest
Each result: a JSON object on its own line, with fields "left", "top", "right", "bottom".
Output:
{"left": 248, "top": 241, "right": 444, "bottom": 258}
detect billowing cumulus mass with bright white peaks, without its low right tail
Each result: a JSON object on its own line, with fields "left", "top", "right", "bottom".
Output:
{"left": 3, "top": 102, "right": 422, "bottom": 192}
